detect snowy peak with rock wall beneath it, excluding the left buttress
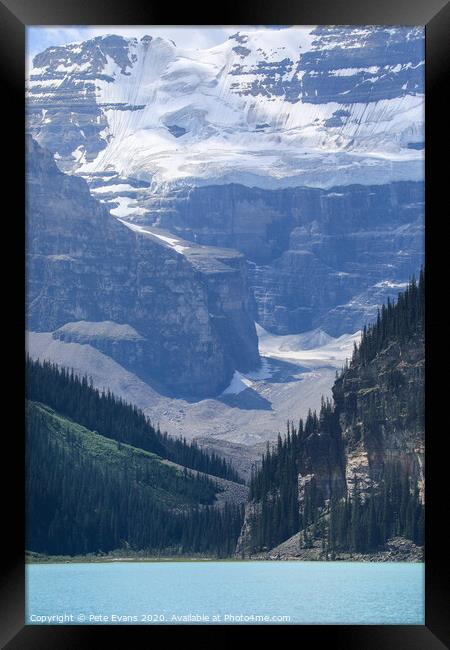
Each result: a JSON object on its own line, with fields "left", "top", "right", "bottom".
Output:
{"left": 27, "top": 26, "right": 424, "bottom": 335}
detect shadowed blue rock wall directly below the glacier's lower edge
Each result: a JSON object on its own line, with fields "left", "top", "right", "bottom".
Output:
{"left": 142, "top": 182, "right": 424, "bottom": 336}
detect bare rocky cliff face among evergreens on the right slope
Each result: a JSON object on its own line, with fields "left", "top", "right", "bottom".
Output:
{"left": 333, "top": 336, "right": 425, "bottom": 498}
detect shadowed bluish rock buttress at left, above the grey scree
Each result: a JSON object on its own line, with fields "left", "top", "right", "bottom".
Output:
{"left": 27, "top": 138, "right": 259, "bottom": 396}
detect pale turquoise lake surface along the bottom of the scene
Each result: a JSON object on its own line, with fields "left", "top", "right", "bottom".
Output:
{"left": 26, "top": 561, "right": 424, "bottom": 625}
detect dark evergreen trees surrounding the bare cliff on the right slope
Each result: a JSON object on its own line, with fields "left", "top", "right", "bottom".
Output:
{"left": 250, "top": 269, "right": 425, "bottom": 555}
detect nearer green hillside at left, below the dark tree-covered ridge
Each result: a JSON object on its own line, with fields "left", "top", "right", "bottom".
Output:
{"left": 26, "top": 401, "right": 242, "bottom": 556}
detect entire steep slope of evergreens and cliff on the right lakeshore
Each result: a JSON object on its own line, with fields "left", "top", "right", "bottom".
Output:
{"left": 237, "top": 272, "right": 425, "bottom": 557}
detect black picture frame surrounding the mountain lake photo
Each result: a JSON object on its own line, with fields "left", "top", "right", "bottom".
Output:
{"left": 0, "top": 0, "right": 450, "bottom": 650}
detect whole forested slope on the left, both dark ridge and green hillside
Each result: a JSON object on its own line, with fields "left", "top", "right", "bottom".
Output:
{"left": 26, "top": 362, "right": 244, "bottom": 557}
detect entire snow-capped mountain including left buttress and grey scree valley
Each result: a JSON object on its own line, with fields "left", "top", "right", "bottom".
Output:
{"left": 27, "top": 27, "right": 424, "bottom": 457}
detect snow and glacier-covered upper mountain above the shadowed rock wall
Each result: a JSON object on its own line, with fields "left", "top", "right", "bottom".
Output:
{"left": 28, "top": 27, "right": 424, "bottom": 192}
